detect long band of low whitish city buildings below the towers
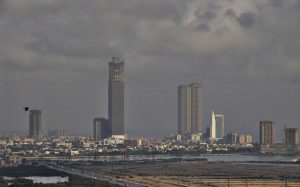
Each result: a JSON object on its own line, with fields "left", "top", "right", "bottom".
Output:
{"left": 0, "top": 136, "right": 254, "bottom": 166}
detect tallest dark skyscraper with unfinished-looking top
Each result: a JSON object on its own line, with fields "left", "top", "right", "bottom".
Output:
{"left": 108, "top": 57, "right": 125, "bottom": 136}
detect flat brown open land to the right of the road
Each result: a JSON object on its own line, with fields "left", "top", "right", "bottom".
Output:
{"left": 67, "top": 160, "right": 300, "bottom": 187}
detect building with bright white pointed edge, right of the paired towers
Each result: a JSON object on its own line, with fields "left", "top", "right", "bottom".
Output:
{"left": 210, "top": 111, "right": 225, "bottom": 139}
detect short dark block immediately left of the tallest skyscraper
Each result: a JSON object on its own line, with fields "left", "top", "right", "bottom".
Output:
{"left": 93, "top": 118, "right": 109, "bottom": 141}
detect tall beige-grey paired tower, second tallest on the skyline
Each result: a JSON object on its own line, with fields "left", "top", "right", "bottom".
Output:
{"left": 178, "top": 83, "right": 203, "bottom": 135}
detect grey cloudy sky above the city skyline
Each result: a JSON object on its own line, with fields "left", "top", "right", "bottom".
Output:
{"left": 0, "top": 0, "right": 300, "bottom": 141}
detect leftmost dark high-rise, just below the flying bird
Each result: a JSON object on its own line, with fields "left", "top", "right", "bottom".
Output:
{"left": 29, "top": 110, "right": 42, "bottom": 139}
